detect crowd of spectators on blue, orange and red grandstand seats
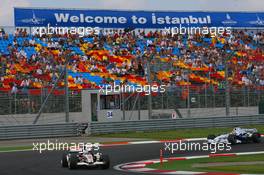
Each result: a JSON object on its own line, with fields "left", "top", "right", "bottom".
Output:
{"left": 0, "top": 28, "right": 264, "bottom": 92}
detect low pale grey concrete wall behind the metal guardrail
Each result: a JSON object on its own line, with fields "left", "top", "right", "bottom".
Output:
{"left": 0, "top": 107, "right": 258, "bottom": 125}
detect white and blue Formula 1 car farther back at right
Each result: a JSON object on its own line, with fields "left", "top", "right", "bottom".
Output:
{"left": 207, "top": 127, "right": 261, "bottom": 145}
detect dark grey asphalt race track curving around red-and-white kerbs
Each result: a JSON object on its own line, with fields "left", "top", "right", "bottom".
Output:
{"left": 0, "top": 142, "right": 264, "bottom": 175}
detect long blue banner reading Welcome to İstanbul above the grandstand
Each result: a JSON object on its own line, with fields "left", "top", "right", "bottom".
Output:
{"left": 14, "top": 8, "right": 264, "bottom": 28}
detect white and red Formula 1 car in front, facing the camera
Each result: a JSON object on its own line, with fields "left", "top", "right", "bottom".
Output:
{"left": 61, "top": 146, "right": 110, "bottom": 169}
